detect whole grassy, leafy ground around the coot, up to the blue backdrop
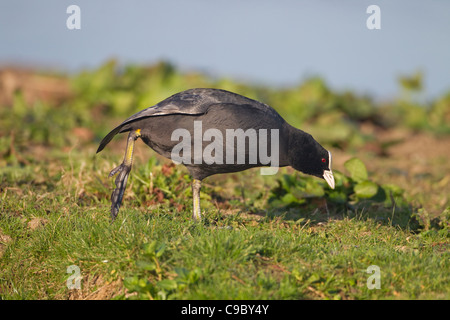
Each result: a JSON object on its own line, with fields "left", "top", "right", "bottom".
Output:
{"left": 0, "top": 61, "right": 450, "bottom": 299}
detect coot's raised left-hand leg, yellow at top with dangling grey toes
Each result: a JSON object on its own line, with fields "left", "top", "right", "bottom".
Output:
{"left": 109, "top": 129, "right": 141, "bottom": 221}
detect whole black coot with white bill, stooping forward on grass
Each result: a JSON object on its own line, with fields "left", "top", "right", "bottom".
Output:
{"left": 97, "top": 89, "right": 334, "bottom": 219}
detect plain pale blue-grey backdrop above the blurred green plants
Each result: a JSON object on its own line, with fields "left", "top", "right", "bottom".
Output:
{"left": 0, "top": 0, "right": 450, "bottom": 99}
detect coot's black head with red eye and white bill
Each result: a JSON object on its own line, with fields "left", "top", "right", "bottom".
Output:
{"left": 289, "top": 132, "right": 335, "bottom": 189}
